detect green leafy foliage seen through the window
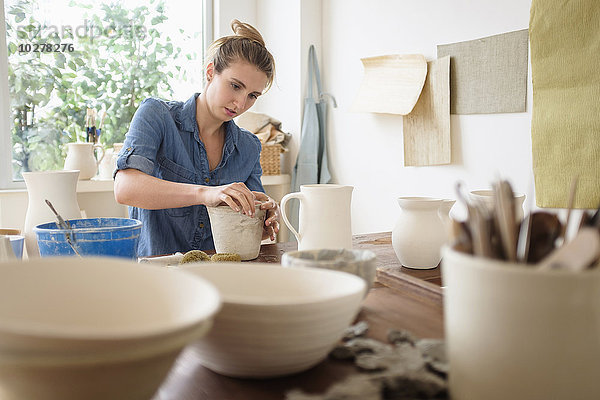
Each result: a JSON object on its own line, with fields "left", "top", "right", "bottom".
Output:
{"left": 6, "top": 0, "right": 196, "bottom": 179}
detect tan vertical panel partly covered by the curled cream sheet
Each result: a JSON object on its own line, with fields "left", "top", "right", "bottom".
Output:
{"left": 402, "top": 57, "right": 451, "bottom": 166}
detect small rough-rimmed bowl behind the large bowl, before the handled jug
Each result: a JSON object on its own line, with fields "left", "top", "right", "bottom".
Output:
{"left": 281, "top": 249, "right": 377, "bottom": 290}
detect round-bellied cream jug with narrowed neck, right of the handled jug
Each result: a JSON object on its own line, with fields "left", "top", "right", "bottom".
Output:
{"left": 392, "top": 197, "right": 454, "bottom": 269}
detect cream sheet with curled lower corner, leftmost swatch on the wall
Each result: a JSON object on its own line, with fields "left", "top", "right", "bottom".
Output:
{"left": 352, "top": 54, "right": 427, "bottom": 115}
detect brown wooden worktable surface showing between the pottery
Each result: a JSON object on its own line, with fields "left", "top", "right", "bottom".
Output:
{"left": 154, "top": 232, "right": 444, "bottom": 400}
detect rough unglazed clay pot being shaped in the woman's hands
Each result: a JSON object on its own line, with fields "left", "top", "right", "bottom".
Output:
{"left": 206, "top": 205, "right": 267, "bottom": 260}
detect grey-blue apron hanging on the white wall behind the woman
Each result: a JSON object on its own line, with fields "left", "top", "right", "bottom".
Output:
{"left": 289, "top": 45, "right": 337, "bottom": 231}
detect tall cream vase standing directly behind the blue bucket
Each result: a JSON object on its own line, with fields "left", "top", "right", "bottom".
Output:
{"left": 23, "top": 170, "right": 81, "bottom": 258}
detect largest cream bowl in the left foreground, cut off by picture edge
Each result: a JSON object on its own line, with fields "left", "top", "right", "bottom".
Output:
{"left": 0, "top": 257, "right": 220, "bottom": 400}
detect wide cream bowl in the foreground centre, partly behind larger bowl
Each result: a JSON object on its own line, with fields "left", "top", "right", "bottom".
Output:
{"left": 182, "top": 263, "right": 366, "bottom": 378}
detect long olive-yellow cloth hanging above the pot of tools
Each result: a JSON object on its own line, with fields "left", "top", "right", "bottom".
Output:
{"left": 529, "top": 0, "right": 600, "bottom": 208}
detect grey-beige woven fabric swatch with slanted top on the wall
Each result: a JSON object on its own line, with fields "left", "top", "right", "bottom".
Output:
{"left": 437, "top": 29, "right": 528, "bottom": 114}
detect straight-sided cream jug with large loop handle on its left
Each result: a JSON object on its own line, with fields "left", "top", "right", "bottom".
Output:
{"left": 281, "top": 184, "right": 354, "bottom": 250}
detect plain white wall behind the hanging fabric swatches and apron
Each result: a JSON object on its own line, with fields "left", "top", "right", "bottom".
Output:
{"left": 215, "top": 0, "right": 534, "bottom": 234}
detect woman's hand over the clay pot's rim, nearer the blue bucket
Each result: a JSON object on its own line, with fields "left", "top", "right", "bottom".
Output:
{"left": 202, "top": 182, "right": 256, "bottom": 217}
